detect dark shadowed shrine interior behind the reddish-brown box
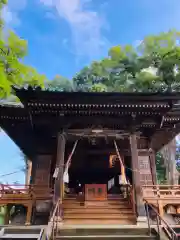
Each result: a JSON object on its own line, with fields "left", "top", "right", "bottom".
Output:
{"left": 65, "top": 137, "right": 132, "bottom": 189}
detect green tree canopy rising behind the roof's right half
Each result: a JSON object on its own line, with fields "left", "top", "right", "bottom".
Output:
{"left": 70, "top": 30, "right": 180, "bottom": 92}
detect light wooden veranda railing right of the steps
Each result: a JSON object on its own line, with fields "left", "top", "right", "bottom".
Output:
{"left": 142, "top": 185, "right": 180, "bottom": 200}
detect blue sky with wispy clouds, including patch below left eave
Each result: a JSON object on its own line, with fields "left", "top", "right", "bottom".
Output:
{"left": 0, "top": 0, "right": 180, "bottom": 182}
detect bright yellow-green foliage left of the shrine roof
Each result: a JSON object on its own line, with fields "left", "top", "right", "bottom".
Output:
{"left": 0, "top": 0, "right": 45, "bottom": 98}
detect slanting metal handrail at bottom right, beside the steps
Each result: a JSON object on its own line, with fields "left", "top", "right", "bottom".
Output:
{"left": 144, "top": 199, "right": 180, "bottom": 240}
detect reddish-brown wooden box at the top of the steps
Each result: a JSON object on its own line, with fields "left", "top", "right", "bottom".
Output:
{"left": 85, "top": 184, "right": 107, "bottom": 201}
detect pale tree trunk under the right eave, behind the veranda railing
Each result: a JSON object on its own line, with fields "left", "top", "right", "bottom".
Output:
{"left": 161, "top": 138, "right": 179, "bottom": 185}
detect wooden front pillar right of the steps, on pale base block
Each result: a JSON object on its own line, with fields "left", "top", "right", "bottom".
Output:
{"left": 130, "top": 133, "right": 147, "bottom": 223}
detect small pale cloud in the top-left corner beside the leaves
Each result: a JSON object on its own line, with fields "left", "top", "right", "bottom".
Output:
{"left": 1, "top": 0, "right": 27, "bottom": 27}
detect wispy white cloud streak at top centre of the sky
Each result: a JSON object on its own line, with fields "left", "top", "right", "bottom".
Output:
{"left": 40, "top": 0, "right": 108, "bottom": 58}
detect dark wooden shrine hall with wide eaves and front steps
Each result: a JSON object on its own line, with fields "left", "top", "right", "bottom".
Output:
{"left": 0, "top": 88, "right": 180, "bottom": 227}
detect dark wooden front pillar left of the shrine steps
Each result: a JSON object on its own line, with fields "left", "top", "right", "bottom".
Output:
{"left": 54, "top": 134, "right": 66, "bottom": 202}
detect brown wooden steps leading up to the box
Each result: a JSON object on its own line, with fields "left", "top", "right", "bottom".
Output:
{"left": 63, "top": 194, "right": 136, "bottom": 225}
